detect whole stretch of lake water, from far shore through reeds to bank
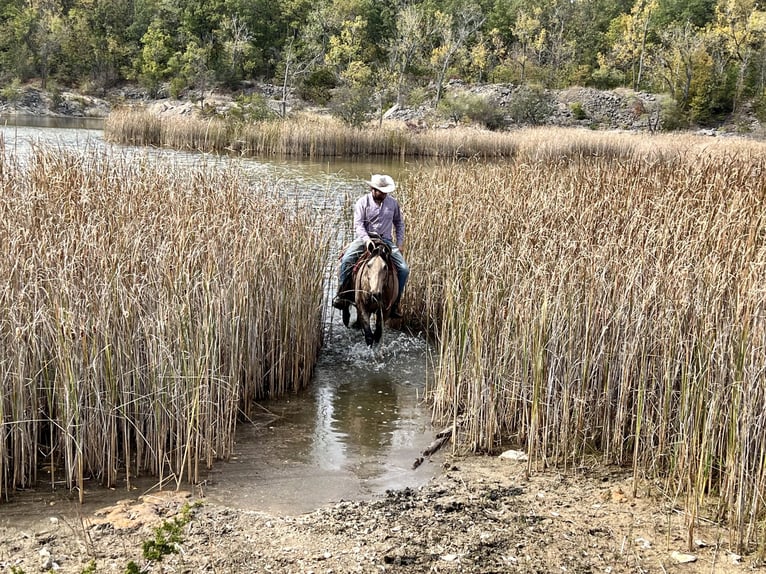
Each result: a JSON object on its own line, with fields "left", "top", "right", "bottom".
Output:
{"left": 0, "top": 124, "right": 441, "bottom": 525}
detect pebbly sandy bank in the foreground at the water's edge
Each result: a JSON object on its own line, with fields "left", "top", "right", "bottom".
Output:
{"left": 0, "top": 457, "right": 756, "bottom": 574}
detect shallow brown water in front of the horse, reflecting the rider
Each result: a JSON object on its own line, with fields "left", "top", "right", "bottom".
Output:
{"left": 205, "top": 316, "right": 441, "bottom": 514}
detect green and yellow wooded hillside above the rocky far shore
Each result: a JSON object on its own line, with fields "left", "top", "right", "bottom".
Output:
{"left": 0, "top": 0, "right": 766, "bottom": 128}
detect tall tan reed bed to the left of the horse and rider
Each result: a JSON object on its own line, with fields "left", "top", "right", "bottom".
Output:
{"left": 0, "top": 148, "right": 328, "bottom": 502}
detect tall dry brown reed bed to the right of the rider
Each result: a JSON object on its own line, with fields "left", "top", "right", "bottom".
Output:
{"left": 400, "top": 130, "right": 766, "bottom": 549}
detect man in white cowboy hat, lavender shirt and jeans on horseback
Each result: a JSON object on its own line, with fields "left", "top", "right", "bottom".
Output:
{"left": 333, "top": 174, "right": 410, "bottom": 319}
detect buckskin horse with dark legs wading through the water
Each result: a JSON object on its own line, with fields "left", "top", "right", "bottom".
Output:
{"left": 343, "top": 239, "right": 399, "bottom": 347}
